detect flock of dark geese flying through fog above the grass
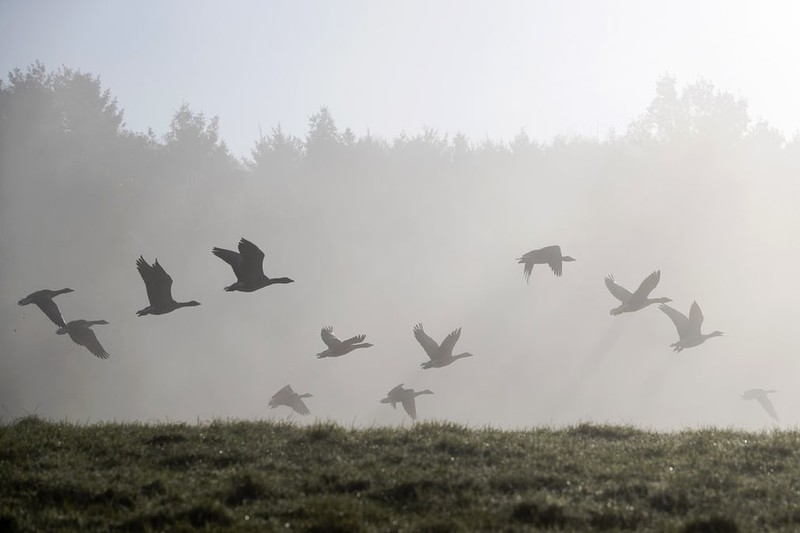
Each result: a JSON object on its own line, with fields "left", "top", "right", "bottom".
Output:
{"left": 19, "top": 242, "right": 779, "bottom": 420}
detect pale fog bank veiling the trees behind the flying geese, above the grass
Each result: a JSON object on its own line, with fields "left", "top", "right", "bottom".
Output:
{"left": 0, "top": 2, "right": 800, "bottom": 429}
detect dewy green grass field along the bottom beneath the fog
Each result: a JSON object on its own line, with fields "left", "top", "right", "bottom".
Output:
{"left": 0, "top": 417, "right": 800, "bottom": 532}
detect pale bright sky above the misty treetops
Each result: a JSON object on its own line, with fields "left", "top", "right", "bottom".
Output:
{"left": 0, "top": 0, "right": 800, "bottom": 155}
